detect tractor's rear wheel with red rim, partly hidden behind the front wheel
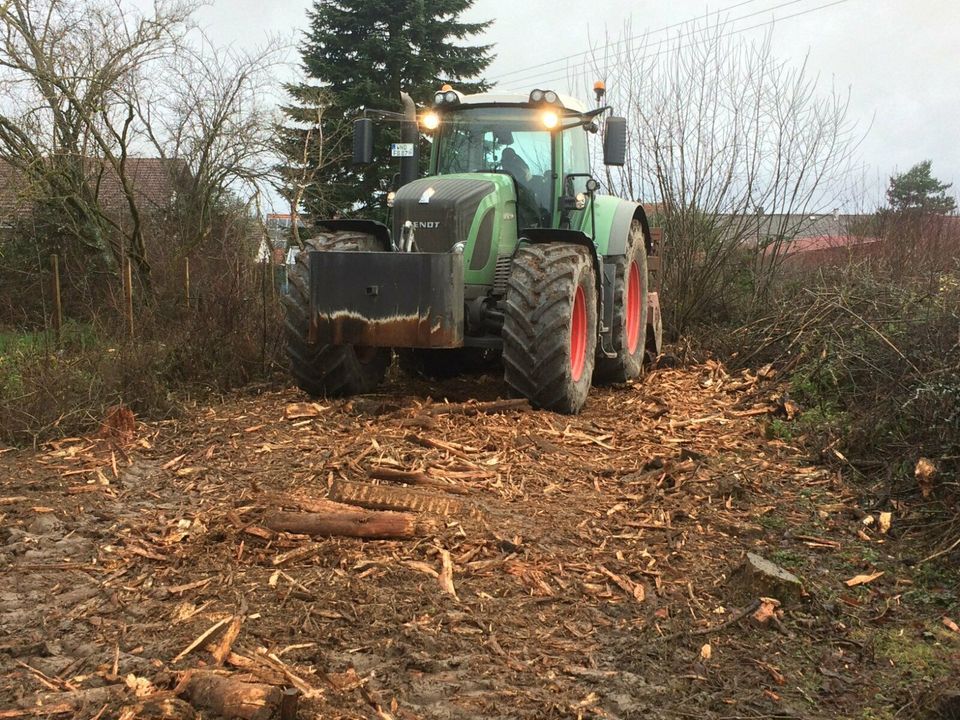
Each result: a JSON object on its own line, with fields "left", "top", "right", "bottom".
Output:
{"left": 593, "top": 220, "right": 650, "bottom": 385}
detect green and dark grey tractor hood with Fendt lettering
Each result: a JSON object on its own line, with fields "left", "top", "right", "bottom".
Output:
{"left": 393, "top": 173, "right": 515, "bottom": 253}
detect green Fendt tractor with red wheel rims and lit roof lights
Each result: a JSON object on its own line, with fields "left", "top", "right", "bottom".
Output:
{"left": 284, "top": 83, "right": 661, "bottom": 413}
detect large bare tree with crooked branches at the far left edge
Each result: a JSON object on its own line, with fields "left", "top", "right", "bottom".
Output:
{"left": 0, "top": 0, "right": 195, "bottom": 281}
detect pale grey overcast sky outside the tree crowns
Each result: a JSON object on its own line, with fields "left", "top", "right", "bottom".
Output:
{"left": 189, "top": 0, "right": 960, "bottom": 209}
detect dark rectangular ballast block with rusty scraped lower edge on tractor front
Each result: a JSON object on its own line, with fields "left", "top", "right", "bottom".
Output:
{"left": 310, "top": 252, "right": 464, "bottom": 348}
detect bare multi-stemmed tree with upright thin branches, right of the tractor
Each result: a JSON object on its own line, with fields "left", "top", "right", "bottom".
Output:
{"left": 580, "top": 22, "right": 857, "bottom": 331}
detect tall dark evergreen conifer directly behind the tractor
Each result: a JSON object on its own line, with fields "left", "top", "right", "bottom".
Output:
{"left": 281, "top": 0, "right": 492, "bottom": 217}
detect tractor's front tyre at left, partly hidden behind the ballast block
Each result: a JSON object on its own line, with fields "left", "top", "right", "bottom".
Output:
{"left": 281, "top": 232, "right": 393, "bottom": 397}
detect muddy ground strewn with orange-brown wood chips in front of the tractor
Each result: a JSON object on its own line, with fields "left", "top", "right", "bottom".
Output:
{"left": 0, "top": 364, "right": 960, "bottom": 720}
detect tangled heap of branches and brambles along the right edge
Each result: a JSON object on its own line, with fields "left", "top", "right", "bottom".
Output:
{"left": 724, "top": 265, "right": 960, "bottom": 516}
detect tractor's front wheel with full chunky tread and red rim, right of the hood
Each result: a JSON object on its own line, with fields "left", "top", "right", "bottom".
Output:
{"left": 503, "top": 244, "right": 597, "bottom": 414}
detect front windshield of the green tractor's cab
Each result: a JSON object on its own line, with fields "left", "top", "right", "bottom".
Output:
{"left": 437, "top": 107, "right": 553, "bottom": 227}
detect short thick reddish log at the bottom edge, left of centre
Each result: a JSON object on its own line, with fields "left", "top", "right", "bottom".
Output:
{"left": 177, "top": 670, "right": 281, "bottom": 720}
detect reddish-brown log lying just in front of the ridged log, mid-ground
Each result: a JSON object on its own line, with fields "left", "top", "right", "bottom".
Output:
{"left": 263, "top": 499, "right": 437, "bottom": 540}
